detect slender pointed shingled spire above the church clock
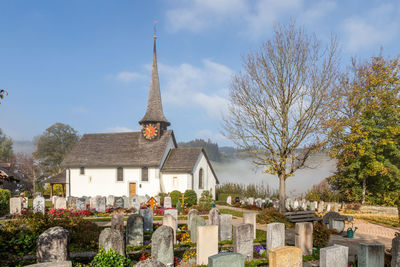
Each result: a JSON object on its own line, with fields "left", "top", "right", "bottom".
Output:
{"left": 139, "top": 36, "right": 171, "bottom": 126}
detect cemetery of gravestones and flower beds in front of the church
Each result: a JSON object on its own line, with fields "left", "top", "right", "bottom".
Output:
{"left": 0, "top": 193, "right": 400, "bottom": 267}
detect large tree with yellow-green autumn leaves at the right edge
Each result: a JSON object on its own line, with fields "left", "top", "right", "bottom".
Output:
{"left": 329, "top": 56, "right": 400, "bottom": 218}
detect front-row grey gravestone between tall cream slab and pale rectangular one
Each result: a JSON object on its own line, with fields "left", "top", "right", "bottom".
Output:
{"left": 233, "top": 223, "right": 254, "bottom": 261}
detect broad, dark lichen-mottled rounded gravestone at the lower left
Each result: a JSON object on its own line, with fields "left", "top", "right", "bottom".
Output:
{"left": 36, "top": 226, "right": 69, "bottom": 262}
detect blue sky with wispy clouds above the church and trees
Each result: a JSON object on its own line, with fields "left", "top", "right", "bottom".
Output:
{"left": 0, "top": 0, "right": 400, "bottom": 145}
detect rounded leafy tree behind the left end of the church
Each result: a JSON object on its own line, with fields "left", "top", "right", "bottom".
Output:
{"left": 33, "top": 123, "right": 79, "bottom": 176}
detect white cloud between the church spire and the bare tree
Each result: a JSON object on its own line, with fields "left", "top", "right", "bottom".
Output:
{"left": 159, "top": 59, "right": 233, "bottom": 117}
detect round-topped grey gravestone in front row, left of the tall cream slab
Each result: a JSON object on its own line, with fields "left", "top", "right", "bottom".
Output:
{"left": 151, "top": 225, "right": 174, "bottom": 266}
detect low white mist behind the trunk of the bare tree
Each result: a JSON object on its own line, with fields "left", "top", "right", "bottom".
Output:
{"left": 213, "top": 154, "right": 336, "bottom": 197}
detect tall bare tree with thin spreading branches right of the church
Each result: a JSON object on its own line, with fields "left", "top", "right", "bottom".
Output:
{"left": 223, "top": 22, "right": 338, "bottom": 211}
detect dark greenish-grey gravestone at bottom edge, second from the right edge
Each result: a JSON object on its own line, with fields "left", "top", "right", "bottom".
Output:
{"left": 358, "top": 243, "right": 385, "bottom": 267}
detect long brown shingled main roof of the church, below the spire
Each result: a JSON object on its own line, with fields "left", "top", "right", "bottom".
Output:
{"left": 62, "top": 130, "right": 176, "bottom": 167}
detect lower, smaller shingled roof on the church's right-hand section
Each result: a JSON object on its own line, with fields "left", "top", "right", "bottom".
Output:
{"left": 161, "top": 147, "right": 219, "bottom": 184}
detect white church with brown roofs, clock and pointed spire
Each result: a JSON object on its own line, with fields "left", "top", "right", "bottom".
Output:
{"left": 62, "top": 36, "right": 219, "bottom": 198}
